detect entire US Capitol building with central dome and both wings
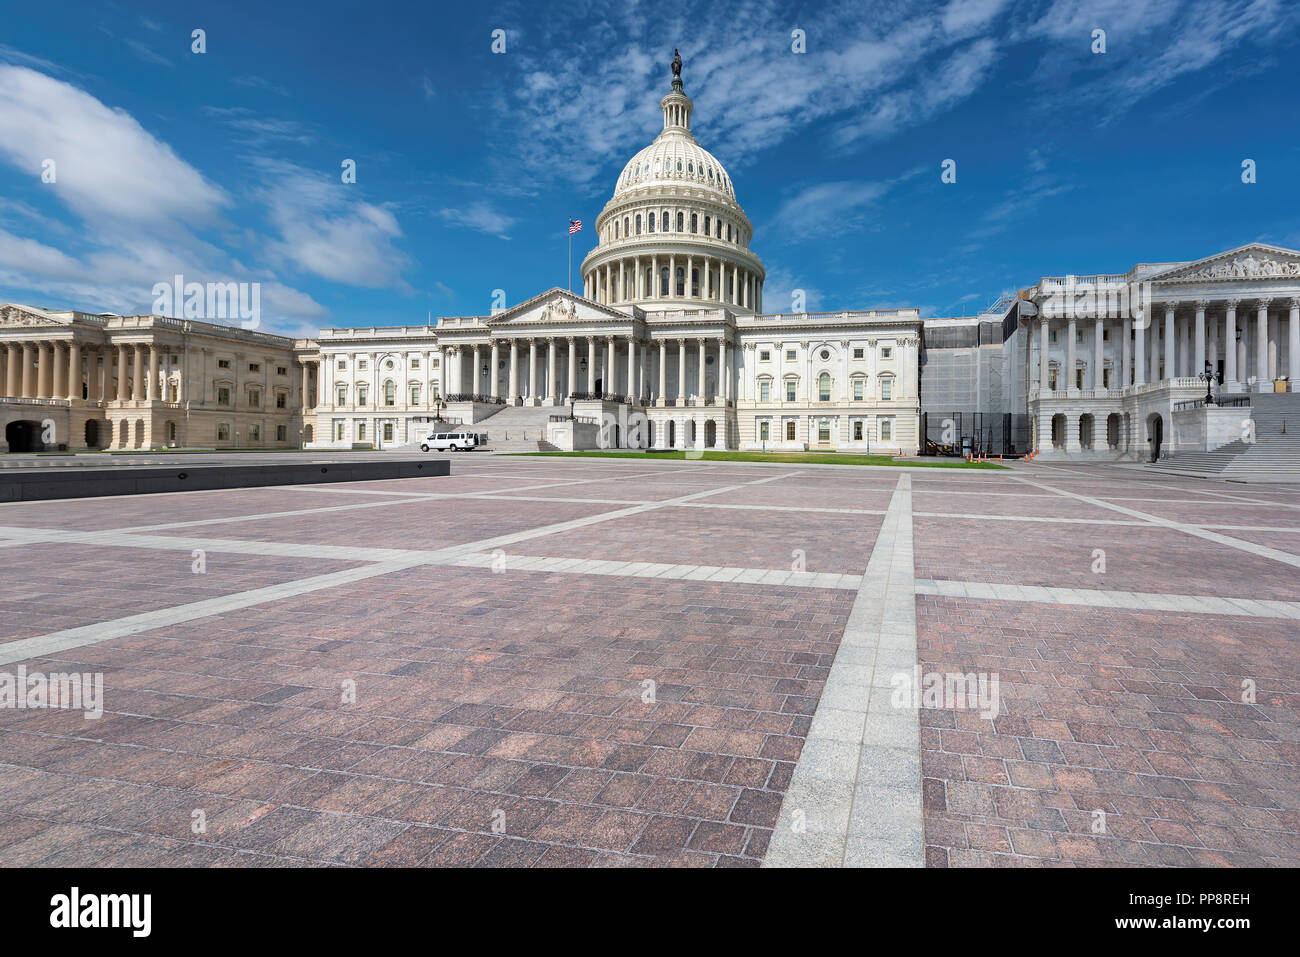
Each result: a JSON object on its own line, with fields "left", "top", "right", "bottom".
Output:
{"left": 0, "top": 59, "right": 1300, "bottom": 460}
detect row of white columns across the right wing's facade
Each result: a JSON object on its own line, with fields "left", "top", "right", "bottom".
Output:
{"left": 1039, "top": 298, "right": 1300, "bottom": 391}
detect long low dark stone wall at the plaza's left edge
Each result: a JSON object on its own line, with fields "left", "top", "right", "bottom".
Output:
{"left": 0, "top": 459, "right": 451, "bottom": 502}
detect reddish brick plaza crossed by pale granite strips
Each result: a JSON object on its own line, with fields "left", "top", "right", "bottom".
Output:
{"left": 0, "top": 455, "right": 1300, "bottom": 867}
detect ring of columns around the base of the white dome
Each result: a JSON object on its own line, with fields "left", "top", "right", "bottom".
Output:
{"left": 584, "top": 254, "right": 763, "bottom": 312}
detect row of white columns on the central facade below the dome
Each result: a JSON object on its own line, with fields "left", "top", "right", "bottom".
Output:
{"left": 442, "top": 335, "right": 732, "bottom": 406}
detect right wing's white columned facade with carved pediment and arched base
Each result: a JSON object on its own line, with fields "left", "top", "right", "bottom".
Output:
{"left": 1022, "top": 243, "right": 1300, "bottom": 459}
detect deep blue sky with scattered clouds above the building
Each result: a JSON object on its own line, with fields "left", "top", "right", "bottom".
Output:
{"left": 0, "top": 0, "right": 1300, "bottom": 335}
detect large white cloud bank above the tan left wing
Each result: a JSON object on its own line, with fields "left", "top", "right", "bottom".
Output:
{"left": 0, "top": 64, "right": 329, "bottom": 328}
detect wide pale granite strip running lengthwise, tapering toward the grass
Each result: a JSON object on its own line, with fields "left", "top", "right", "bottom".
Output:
{"left": 763, "top": 473, "right": 924, "bottom": 867}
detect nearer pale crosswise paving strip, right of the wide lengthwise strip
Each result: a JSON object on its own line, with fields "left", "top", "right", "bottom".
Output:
{"left": 917, "top": 579, "right": 1300, "bottom": 619}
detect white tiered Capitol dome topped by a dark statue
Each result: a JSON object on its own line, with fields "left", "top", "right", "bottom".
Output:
{"left": 582, "top": 51, "right": 766, "bottom": 312}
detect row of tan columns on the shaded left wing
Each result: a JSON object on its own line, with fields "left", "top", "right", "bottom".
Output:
{"left": 0, "top": 339, "right": 159, "bottom": 402}
